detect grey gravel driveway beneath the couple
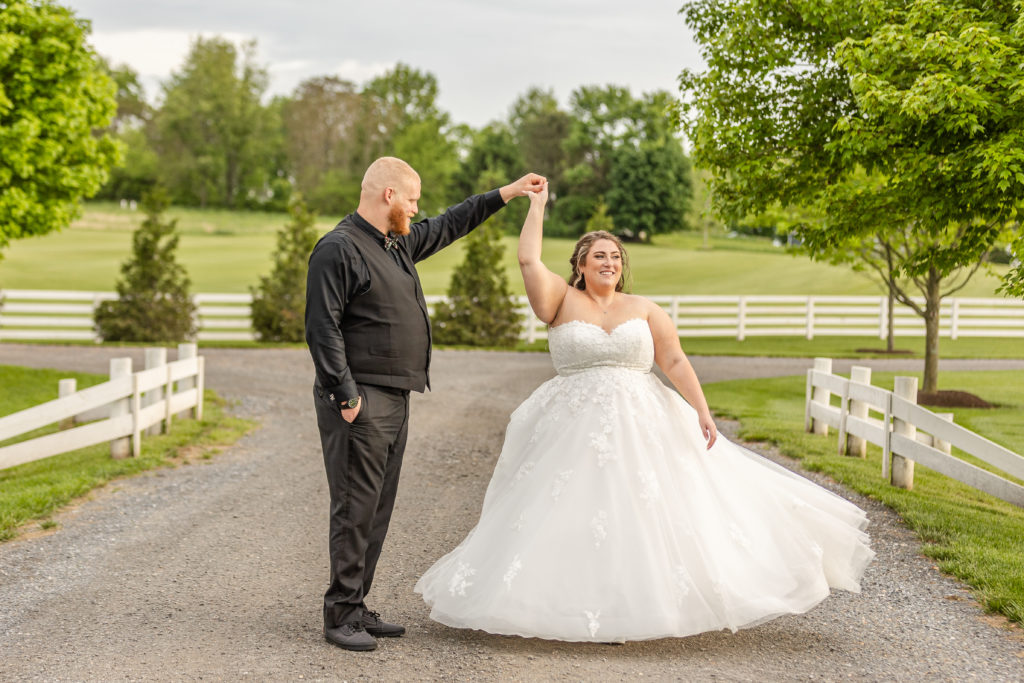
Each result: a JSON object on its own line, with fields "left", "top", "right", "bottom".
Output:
{"left": 0, "top": 344, "right": 1024, "bottom": 681}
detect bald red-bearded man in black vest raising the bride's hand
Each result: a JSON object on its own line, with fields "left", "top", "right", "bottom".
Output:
{"left": 305, "top": 157, "right": 545, "bottom": 650}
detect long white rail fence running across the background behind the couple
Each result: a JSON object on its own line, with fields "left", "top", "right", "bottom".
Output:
{"left": 0, "top": 290, "right": 1024, "bottom": 342}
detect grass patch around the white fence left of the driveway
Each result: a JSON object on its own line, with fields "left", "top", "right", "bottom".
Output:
{"left": 0, "top": 366, "right": 253, "bottom": 541}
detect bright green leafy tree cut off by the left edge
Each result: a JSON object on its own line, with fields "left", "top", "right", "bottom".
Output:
{"left": 0, "top": 0, "right": 118, "bottom": 258}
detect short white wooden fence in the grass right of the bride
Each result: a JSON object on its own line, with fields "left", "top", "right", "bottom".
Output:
{"left": 805, "top": 358, "right": 1024, "bottom": 507}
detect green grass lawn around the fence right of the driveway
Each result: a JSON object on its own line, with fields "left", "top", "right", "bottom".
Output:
{"left": 705, "top": 371, "right": 1024, "bottom": 624}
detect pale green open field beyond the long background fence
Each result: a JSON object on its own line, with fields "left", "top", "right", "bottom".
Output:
{"left": 0, "top": 202, "right": 1006, "bottom": 296}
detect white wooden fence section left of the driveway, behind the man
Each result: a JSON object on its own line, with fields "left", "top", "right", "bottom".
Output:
{"left": 0, "top": 344, "right": 206, "bottom": 469}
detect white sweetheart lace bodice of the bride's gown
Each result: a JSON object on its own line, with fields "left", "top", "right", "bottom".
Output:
{"left": 548, "top": 317, "right": 654, "bottom": 375}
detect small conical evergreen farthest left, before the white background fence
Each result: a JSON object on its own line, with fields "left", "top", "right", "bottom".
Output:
{"left": 95, "top": 188, "right": 196, "bottom": 342}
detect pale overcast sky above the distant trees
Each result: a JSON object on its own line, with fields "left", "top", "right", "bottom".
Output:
{"left": 61, "top": 0, "right": 701, "bottom": 126}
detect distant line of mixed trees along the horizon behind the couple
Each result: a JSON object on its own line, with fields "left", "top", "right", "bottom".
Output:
{"left": 99, "top": 37, "right": 692, "bottom": 237}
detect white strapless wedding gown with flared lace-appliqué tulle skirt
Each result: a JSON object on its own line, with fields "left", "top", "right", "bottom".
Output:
{"left": 416, "top": 318, "right": 873, "bottom": 642}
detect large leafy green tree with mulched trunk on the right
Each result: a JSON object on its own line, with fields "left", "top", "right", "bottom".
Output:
{"left": 680, "top": 0, "right": 1024, "bottom": 391}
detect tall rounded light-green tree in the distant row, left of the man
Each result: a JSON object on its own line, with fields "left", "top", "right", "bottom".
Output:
{"left": 156, "top": 37, "right": 273, "bottom": 208}
